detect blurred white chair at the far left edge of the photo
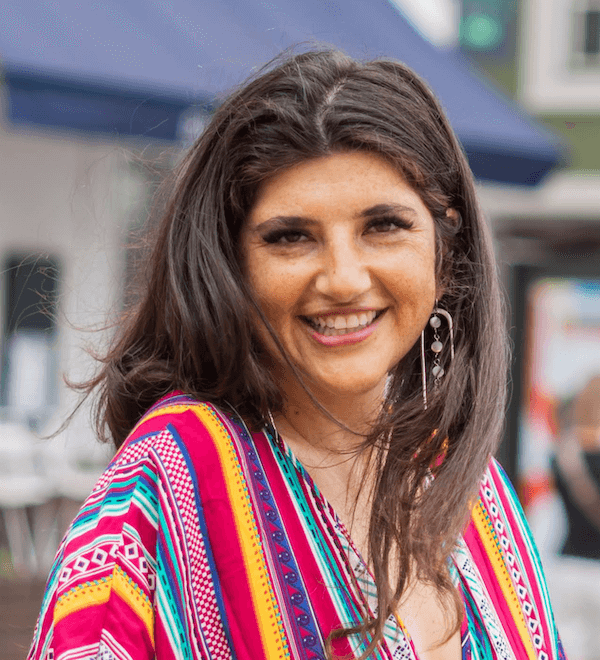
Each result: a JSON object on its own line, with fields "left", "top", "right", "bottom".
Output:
{"left": 0, "top": 422, "right": 52, "bottom": 575}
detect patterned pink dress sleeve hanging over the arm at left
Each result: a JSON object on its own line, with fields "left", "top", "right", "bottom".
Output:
{"left": 28, "top": 434, "right": 158, "bottom": 660}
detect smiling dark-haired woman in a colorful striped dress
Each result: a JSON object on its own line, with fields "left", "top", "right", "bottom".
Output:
{"left": 29, "top": 51, "right": 564, "bottom": 660}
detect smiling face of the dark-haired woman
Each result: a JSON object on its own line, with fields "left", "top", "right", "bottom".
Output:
{"left": 241, "top": 152, "right": 436, "bottom": 402}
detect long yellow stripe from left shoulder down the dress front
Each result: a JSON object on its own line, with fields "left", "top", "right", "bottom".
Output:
{"left": 136, "top": 403, "right": 290, "bottom": 660}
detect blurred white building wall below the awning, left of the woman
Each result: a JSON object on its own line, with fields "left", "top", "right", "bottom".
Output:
{"left": 0, "top": 114, "right": 141, "bottom": 442}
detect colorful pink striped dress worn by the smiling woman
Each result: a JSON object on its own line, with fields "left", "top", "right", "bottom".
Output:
{"left": 28, "top": 394, "right": 564, "bottom": 660}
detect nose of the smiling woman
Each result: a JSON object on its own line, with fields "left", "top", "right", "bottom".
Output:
{"left": 315, "top": 238, "right": 372, "bottom": 302}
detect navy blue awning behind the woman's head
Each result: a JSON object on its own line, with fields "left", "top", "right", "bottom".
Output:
{"left": 0, "top": 0, "right": 562, "bottom": 185}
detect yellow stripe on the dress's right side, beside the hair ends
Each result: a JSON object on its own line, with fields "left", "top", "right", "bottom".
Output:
{"left": 473, "top": 500, "right": 537, "bottom": 660}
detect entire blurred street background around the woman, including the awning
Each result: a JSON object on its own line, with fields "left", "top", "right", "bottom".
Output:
{"left": 0, "top": 0, "right": 600, "bottom": 660}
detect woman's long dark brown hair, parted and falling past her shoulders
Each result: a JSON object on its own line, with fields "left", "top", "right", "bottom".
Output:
{"left": 84, "top": 50, "right": 506, "bottom": 657}
